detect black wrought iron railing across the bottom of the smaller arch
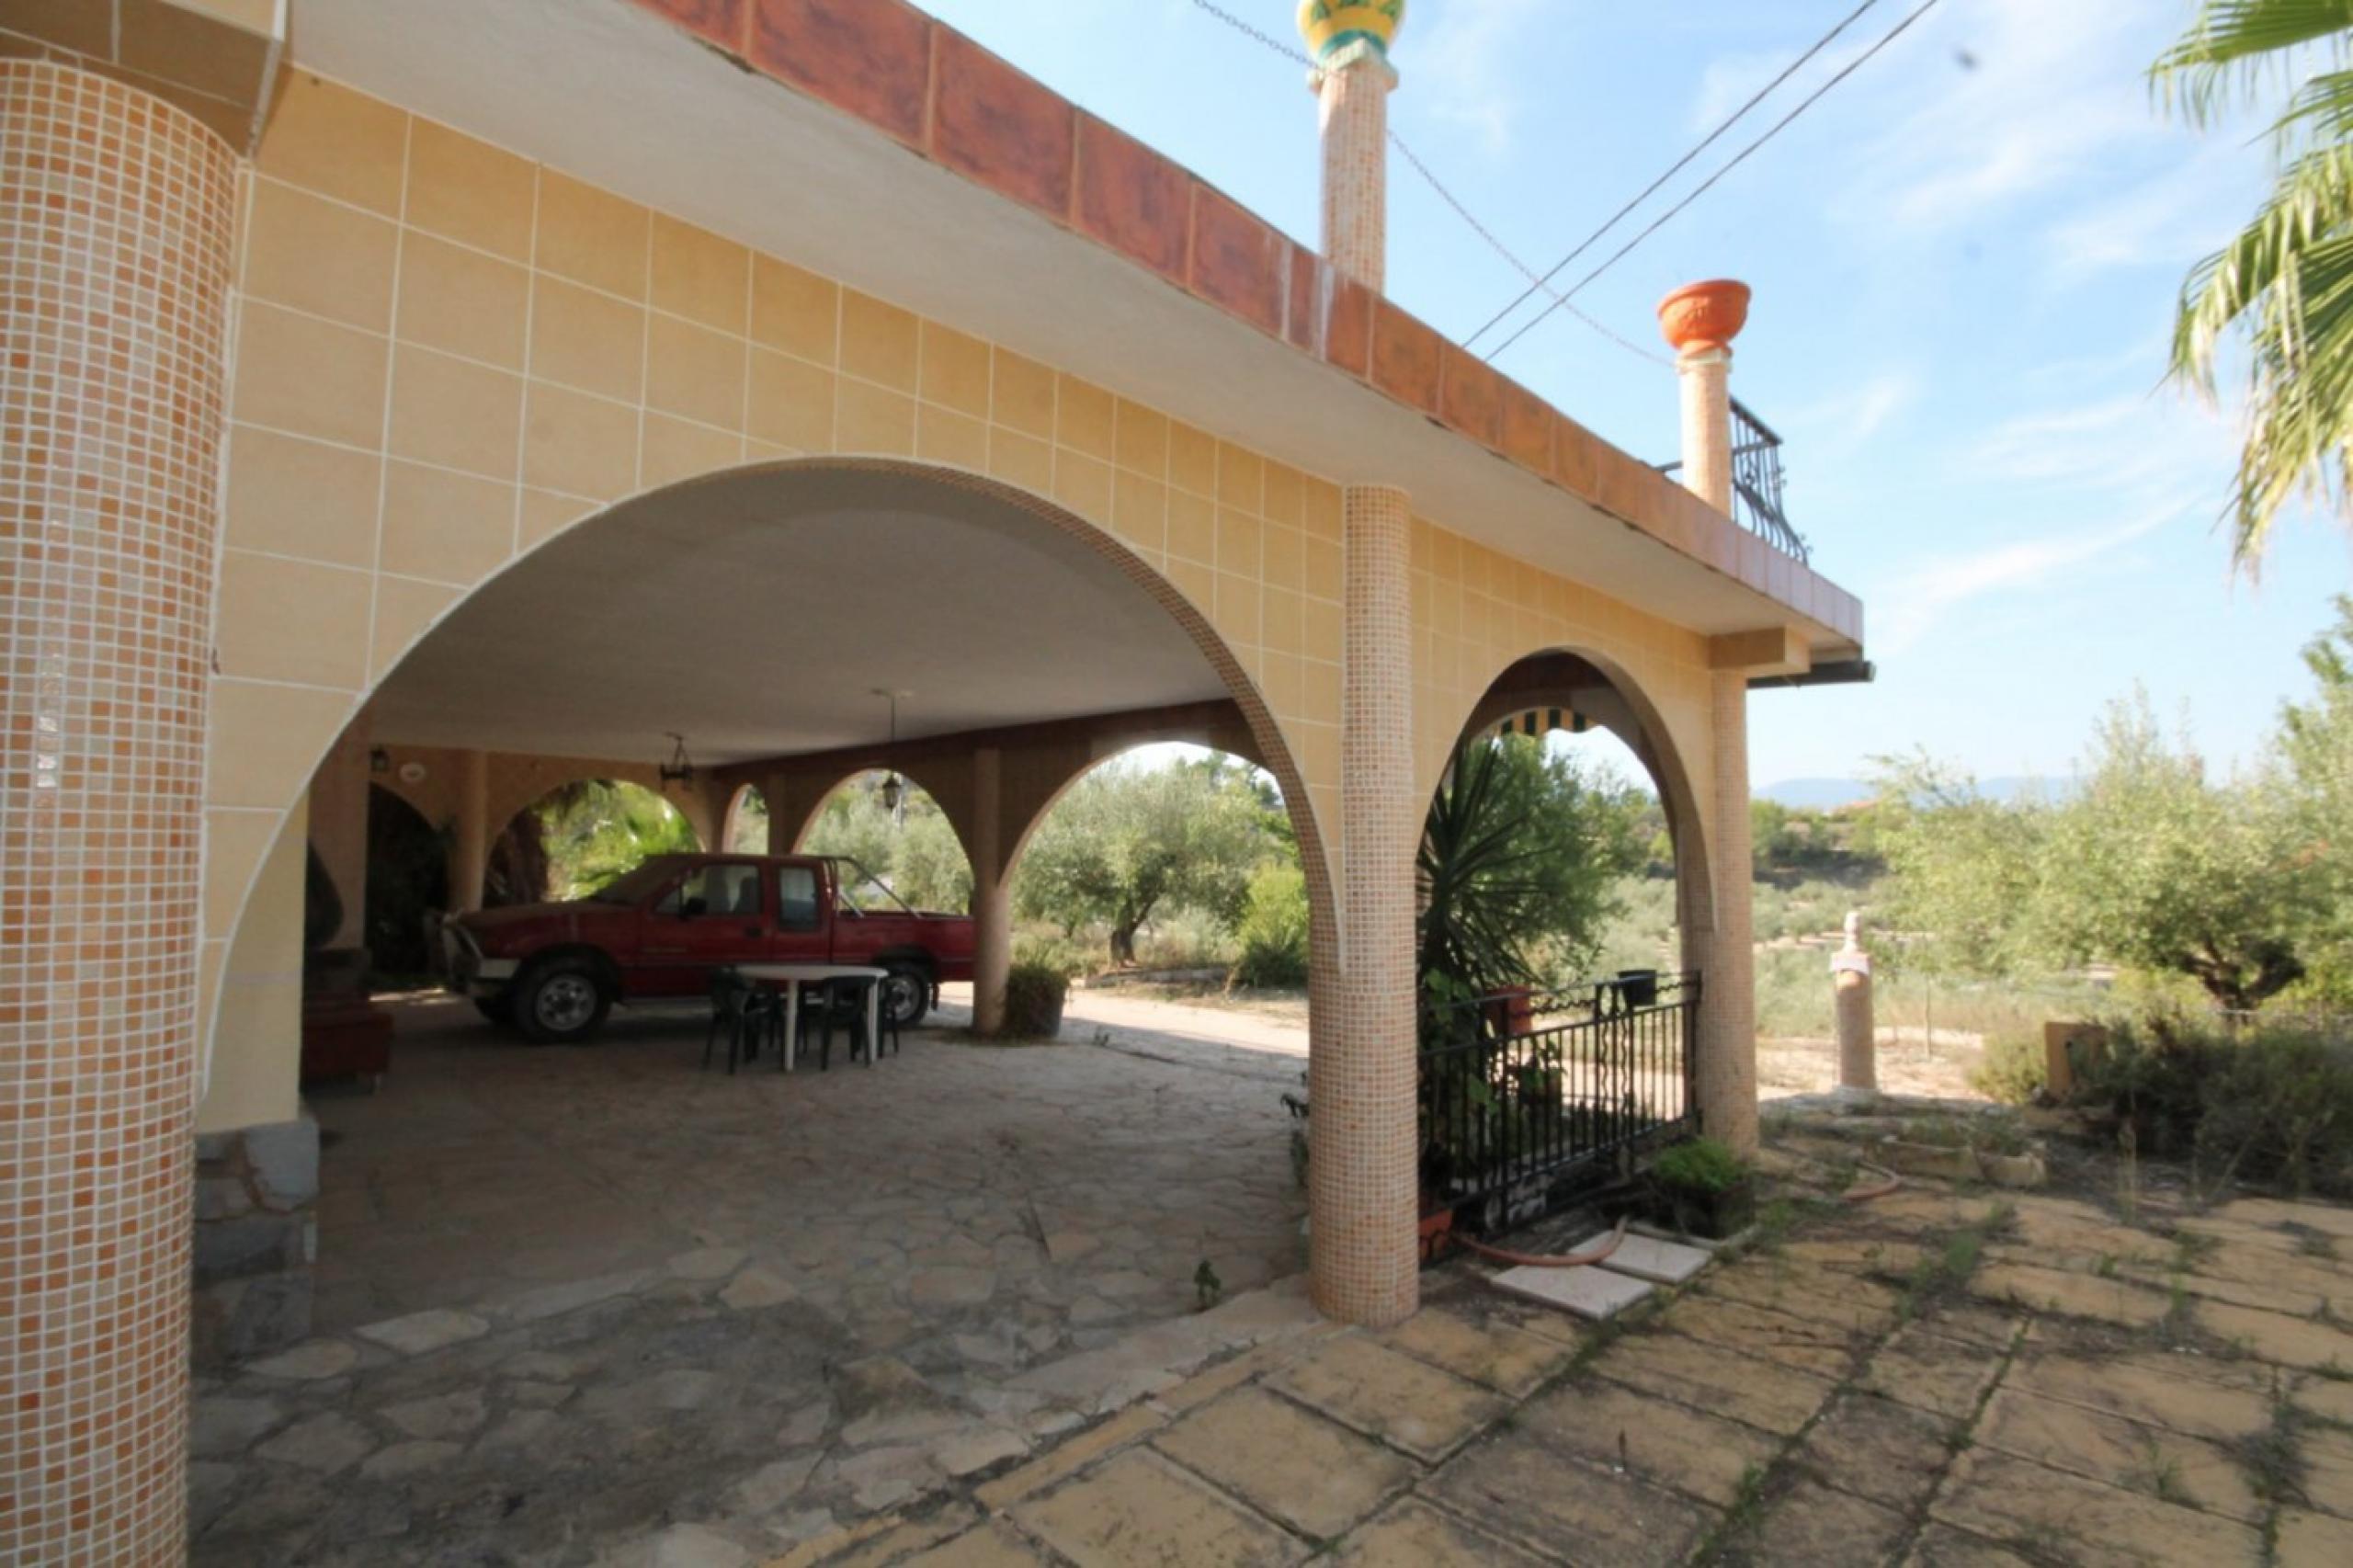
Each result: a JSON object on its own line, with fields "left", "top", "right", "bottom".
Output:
{"left": 1419, "top": 970, "right": 1699, "bottom": 1229}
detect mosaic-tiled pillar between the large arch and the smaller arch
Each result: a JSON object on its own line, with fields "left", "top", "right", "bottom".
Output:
{"left": 1308, "top": 485, "right": 1424, "bottom": 1324}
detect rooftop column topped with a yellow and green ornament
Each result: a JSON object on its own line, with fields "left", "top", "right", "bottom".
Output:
{"left": 1299, "top": 0, "right": 1404, "bottom": 294}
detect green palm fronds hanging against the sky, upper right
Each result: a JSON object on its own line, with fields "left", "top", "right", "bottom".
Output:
{"left": 2151, "top": 0, "right": 2353, "bottom": 577}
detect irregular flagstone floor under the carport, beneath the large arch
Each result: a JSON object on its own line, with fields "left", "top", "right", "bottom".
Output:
{"left": 190, "top": 1001, "right": 1315, "bottom": 1565}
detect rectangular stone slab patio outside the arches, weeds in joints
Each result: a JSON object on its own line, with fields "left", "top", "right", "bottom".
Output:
{"left": 795, "top": 1152, "right": 2353, "bottom": 1568}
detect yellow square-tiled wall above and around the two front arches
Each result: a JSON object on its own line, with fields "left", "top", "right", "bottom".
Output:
{"left": 205, "top": 73, "right": 1706, "bottom": 1111}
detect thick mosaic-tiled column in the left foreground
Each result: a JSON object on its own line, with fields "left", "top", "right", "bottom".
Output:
{"left": 0, "top": 59, "right": 235, "bottom": 1563}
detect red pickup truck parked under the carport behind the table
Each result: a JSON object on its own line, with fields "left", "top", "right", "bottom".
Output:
{"left": 442, "top": 855, "right": 972, "bottom": 1043}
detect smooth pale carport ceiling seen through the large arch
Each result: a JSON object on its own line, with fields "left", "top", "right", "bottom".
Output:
{"left": 371, "top": 469, "right": 1226, "bottom": 763}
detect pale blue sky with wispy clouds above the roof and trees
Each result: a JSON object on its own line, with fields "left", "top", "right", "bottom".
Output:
{"left": 923, "top": 0, "right": 2353, "bottom": 787}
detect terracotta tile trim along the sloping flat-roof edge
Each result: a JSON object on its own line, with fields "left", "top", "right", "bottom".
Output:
{"left": 631, "top": 0, "right": 1861, "bottom": 638}
